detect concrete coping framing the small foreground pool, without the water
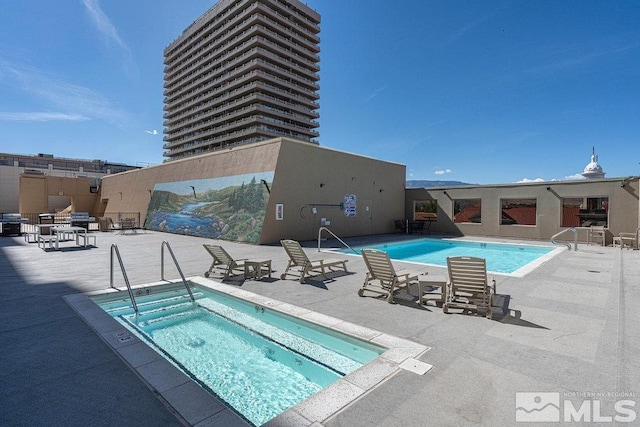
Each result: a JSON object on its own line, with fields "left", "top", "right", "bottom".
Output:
{"left": 63, "top": 276, "right": 432, "bottom": 426}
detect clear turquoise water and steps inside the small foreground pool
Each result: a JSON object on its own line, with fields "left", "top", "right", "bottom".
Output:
{"left": 96, "top": 285, "right": 386, "bottom": 425}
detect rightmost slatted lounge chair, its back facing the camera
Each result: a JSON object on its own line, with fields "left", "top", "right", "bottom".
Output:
{"left": 442, "top": 256, "right": 496, "bottom": 319}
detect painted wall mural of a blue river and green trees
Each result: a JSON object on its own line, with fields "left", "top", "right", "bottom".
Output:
{"left": 145, "top": 172, "right": 274, "bottom": 243}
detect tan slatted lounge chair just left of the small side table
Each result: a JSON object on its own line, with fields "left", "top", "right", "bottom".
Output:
{"left": 358, "top": 249, "right": 426, "bottom": 303}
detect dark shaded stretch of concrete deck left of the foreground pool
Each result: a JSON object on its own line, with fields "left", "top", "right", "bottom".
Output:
{"left": 0, "top": 237, "right": 182, "bottom": 426}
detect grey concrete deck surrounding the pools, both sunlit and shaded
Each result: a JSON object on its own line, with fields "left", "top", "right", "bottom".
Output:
{"left": 0, "top": 231, "right": 640, "bottom": 426}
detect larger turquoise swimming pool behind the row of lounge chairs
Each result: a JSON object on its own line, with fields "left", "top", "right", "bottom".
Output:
{"left": 340, "top": 238, "right": 563, "bottom": 276}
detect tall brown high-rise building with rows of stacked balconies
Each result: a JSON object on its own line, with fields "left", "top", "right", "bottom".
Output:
{"left": 163, "top": 0, "right": 320, "bottom": 160}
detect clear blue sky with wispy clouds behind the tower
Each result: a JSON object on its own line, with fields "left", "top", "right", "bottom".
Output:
{"left": 0, "top": 0, "right": 640, "bottom": 184}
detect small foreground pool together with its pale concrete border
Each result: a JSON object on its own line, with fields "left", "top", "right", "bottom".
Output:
{"left": 79, "top": 277, "right": 431, "bottom": 425}
